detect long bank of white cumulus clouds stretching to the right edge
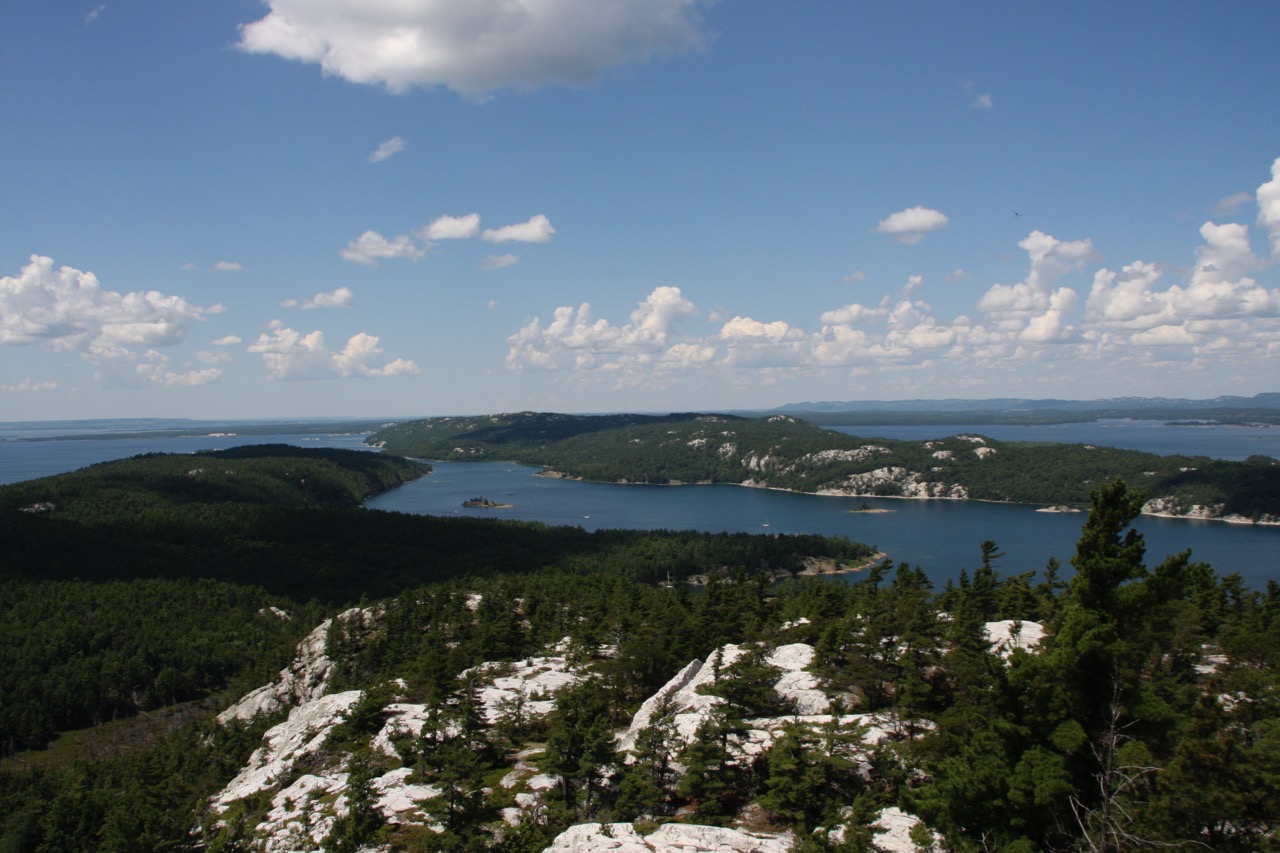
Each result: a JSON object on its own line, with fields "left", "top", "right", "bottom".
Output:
{"left": 508, "top": 156, "right": 1280, "bottom": 394}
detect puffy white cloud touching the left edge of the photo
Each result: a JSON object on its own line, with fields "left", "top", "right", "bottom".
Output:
{"left": 0, "top": 255, "right": 212, "bottom": 353}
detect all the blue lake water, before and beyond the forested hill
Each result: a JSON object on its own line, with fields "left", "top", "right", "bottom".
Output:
{"left": 10, "top": 421, "right": 1280, "bottom": 588}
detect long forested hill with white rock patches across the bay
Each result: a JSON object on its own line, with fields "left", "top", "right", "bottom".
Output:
{"left": 367, "top": 412, "right": 1280, "bottom": 521}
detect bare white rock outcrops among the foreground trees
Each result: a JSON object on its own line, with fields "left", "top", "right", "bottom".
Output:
{"left": 209, "top": 608, "right": 1043, "bottom": 853}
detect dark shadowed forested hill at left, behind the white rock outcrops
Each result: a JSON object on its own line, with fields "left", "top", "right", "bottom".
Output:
{"left": 0, "top": 446, "right": 872, "bottom": 754}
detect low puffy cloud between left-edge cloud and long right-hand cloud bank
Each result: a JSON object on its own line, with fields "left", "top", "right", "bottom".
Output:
{"left": 248, "top": 323, "right": 421, "bottom": 379}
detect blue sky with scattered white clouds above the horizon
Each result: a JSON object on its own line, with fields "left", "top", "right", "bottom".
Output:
{"left": 0, "top": 0, "right": 1280, "bottom": 421}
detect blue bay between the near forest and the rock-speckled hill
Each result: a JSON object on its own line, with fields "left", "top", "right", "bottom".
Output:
{"left": 366, "top": 462, "right": 1280, "bottom": 589}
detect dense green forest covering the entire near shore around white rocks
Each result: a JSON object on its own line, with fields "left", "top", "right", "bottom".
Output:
{"left": 0, "top": 448, "right": 1280, "bottom": 852}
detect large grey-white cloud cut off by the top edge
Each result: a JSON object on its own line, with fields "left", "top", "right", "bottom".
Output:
{"left": 239, "top": 0, "right": 705, "bottom": 96}
